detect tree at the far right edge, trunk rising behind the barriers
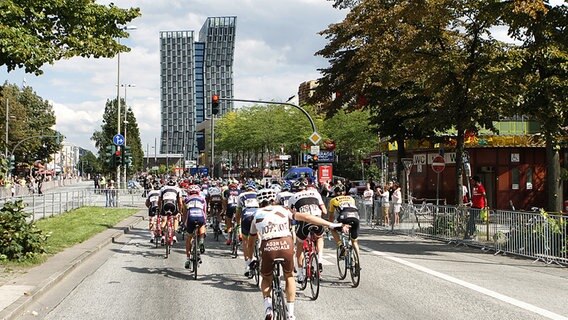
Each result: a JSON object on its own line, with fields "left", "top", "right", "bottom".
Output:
{"left": 503, "top": 1, "right": 568, "bottom": 212}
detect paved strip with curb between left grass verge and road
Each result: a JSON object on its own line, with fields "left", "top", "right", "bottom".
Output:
{"left": 0, "top": 210, "right": 146, "bottom": 320}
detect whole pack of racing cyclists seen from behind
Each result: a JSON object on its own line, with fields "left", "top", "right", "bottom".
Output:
{"left": 146, "top": 177, "right": 359, "bottom": 319}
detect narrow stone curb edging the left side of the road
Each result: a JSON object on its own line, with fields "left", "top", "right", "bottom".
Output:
{"left": 0, "top": 210, "right": 146, "bottom": 320}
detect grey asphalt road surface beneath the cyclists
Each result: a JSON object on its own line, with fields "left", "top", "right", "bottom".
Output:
{"left": 14, "top": 221, "right": 568, "bottom": 320}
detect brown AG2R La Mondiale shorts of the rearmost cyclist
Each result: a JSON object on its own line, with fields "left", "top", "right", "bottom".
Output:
{"left": 260, "top": 237, "right": 294, "bottom": 277}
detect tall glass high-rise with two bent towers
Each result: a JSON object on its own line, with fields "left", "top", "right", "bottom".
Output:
{"left": 160, "top": 17, "right": 237, "bottom": 160}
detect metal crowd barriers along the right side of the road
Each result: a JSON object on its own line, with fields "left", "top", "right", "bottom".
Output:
{"left": 356, "top": 199, "right": 568, "bottom": 265}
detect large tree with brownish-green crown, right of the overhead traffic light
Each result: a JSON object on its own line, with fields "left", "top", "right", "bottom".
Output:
{"left": 316, "top": 0, "right": 510, "bottom": 199}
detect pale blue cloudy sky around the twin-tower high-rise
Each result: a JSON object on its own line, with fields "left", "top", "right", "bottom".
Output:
{"left": 0, "top": 0, "right": 347, "bottom": 154}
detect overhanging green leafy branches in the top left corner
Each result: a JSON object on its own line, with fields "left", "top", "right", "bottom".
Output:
{"left": 0, "top": 0, "right": 140, "bottom": 74}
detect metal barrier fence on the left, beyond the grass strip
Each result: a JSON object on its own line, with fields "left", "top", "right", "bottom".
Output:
{"left": 0, "top": 189, "right": 146, "bottom": 220}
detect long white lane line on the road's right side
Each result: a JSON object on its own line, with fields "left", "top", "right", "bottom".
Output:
{"left": 359, "top": 245, "right": 568, "bottom": 320}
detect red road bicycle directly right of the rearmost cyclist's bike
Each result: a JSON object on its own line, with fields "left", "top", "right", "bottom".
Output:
{"left": 299, "top": 227, "right": 321, "bottom": 300}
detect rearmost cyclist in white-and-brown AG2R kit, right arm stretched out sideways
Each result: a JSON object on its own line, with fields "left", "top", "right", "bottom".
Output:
{"left": 248, "top": 189, "right": 342, "bottom": 319}
